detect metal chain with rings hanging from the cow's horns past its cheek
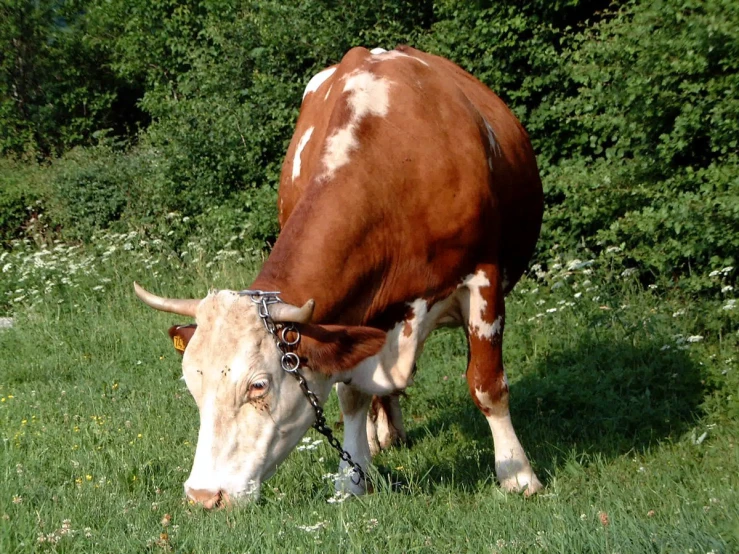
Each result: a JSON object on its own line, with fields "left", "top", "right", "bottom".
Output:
{"left": 239, "top": 290, "right": 366, "bottom": 485}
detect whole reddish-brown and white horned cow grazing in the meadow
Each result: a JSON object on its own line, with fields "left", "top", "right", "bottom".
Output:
{"left": 136, "top": 46, "right": 543, "bottom": 507}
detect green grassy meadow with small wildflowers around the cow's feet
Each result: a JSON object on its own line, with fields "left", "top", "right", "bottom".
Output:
{"left": 0, "top": 233, "right": 739, "bottom": 553}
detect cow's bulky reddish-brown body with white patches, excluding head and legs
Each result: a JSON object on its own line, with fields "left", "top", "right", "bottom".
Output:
{"left": 265, "top": 47, "right": 542, "bottom": 323}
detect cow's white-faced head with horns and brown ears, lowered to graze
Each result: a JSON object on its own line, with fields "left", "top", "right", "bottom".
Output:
{"left": 134, "top": 283, "right": 385, "bottom": 508}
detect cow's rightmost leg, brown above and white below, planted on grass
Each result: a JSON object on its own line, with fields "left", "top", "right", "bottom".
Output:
{"left": 462, "top": 264, "right": 542, "bottom": 495}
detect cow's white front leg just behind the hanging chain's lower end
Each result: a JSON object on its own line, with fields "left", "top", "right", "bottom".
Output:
{"left": 336, "top": 383, "right": 372, "bottom": 495}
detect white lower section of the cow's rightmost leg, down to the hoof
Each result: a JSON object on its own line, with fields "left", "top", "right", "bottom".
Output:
{"left": 475, "top": 384, "right": 541, "bottom": 494}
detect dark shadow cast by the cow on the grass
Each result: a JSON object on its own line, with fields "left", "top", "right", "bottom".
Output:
{"left": 394, "top": 338, "right": 704, "bottom": 489}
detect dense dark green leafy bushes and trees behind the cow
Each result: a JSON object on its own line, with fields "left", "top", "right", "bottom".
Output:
{"left": 0, "top": 0, "right": 739, "bottom": 292}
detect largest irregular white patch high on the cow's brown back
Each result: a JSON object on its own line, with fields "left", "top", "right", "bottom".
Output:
{"left": 323, "top": 70, "right": 391, "bottom": 178}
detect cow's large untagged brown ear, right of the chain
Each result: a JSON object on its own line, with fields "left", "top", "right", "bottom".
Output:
{"left": 294, "top": 324, "right": 386, "bottom": 375}
